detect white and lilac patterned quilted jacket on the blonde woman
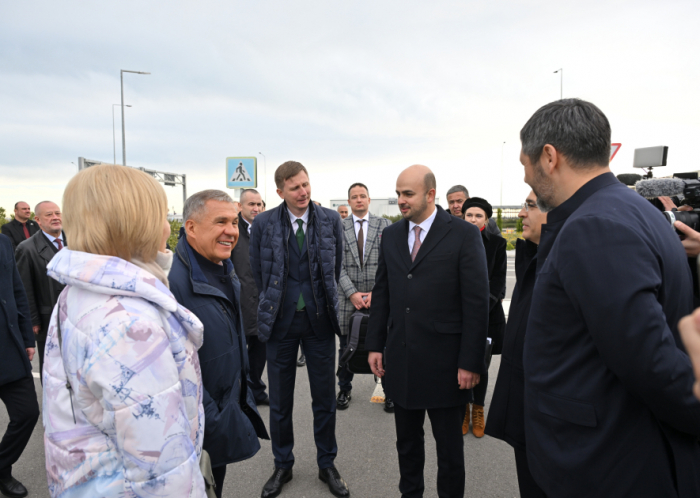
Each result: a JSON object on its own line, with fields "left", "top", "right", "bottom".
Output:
{"left": 42, "top": 249, "right": 205, "bottom": 498}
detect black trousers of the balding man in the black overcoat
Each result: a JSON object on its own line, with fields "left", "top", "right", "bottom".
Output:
{"left": 394, "top": 405, "right": 467, "bottom": 498}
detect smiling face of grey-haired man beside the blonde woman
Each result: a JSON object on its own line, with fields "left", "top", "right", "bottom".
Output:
{"left": 185, "top": 200, "right": 238, "bottom": 264}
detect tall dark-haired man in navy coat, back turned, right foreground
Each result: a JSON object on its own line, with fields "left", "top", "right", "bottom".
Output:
{"left": 520, "top": 99, "right": 700, "bottom": 497}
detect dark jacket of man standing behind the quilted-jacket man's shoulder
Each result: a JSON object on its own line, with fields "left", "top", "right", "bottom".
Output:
{"left": 231, "top": 214, "right": 259, "bottom": 336}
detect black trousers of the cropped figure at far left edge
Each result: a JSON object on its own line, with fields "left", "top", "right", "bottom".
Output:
{"left": 0, "top": 377, "right": 39, "bottom": 479}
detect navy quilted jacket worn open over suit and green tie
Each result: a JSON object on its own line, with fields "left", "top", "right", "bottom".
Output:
{"left": 250, "top": 202, "right": 343, "bottom": 342}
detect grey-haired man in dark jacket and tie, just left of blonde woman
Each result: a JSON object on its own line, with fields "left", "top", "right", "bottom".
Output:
{"left": 15, "top": 201, "right": 66, "bottom": 383}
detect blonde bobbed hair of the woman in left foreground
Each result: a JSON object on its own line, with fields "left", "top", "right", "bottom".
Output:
{"left": 63, "top": 164, "right": 168, "bottom": 263}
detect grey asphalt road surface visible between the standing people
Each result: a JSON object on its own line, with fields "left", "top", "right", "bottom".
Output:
{"left": 0, "top": 251, "right": 519, "bottom": 498}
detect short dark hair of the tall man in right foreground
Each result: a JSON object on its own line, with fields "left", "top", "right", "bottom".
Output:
{"left": 520, "top": 99, "right": 611, "bottom": 169}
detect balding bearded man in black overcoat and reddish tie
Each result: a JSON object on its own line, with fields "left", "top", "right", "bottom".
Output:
{"left": 365, "top": 165, "right": 489, "bottom": 498}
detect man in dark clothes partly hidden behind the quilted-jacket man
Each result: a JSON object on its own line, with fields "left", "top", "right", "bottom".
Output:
{"left": 231, "top": 188, "right": 270, "bottom": 405}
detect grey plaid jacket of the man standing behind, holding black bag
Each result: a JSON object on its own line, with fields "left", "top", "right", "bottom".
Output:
{"left": 338, "top": 213, "right": 391, "bottom": 335}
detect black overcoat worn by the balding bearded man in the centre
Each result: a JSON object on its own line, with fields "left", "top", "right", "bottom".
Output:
{"left": 365, "top": 206, "right": 489, "bottom": 409}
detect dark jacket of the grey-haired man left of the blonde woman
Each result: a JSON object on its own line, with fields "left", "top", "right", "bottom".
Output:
{"left": 15, "top": 230, "right": 68, "bottom": 340}
